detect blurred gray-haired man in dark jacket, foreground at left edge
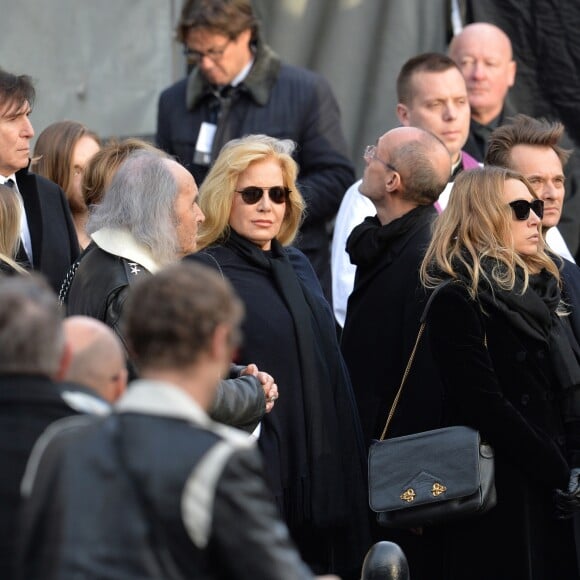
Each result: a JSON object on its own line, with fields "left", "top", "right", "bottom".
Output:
{"left": 0, "top": 273, "right": 78, "bottom": 579}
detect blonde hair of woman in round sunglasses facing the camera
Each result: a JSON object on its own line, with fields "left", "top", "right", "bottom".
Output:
{"left": 197, "top": 135, "right": 305, "bottom": 250}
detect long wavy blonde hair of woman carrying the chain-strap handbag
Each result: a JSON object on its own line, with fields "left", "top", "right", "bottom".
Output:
{"left": 420, "top": 166, "right": 560, "bottom": 298}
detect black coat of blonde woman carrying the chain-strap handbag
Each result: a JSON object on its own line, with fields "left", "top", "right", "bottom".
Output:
{"left": 422, "top": 284, "right": 578, "bottom": 580}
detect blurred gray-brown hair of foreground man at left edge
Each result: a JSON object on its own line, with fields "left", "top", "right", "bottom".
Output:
{"left": 0, "top": 273, "right": 64, "bottom": 378}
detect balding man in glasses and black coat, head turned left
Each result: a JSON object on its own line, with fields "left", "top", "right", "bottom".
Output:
{"left": 341, "top": 127, "right": 451, "bottom": 445}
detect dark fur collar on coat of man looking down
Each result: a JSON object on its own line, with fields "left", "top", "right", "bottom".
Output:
{"left": 185, "top": 39, "right": 281, "bottom": 110}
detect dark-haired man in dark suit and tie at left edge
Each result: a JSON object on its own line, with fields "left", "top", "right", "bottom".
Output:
{"left": 0, "top": 69, "right": 79, "bottom": 292}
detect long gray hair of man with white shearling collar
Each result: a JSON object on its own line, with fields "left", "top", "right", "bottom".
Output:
{"left": 87, "top": 151, "right": 179, "bottom": 265}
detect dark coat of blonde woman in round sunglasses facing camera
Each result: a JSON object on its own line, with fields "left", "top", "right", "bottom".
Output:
{"left": 186, "top": 246, "right": 370, "bottom": 580}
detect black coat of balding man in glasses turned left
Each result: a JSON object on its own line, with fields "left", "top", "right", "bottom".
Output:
{"left": 341, "top": 207, "right": 441, "bottom": 445}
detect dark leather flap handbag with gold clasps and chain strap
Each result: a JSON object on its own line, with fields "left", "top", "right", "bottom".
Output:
{"left": 368, "top": 286, "right": 497, "bottom": 528}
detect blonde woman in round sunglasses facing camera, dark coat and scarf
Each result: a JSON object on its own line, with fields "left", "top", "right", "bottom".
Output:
{"left": 189, "top": 135, "right": 370, "bottom": 580}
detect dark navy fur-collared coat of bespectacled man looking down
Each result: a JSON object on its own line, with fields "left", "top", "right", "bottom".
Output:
{"left": 156, "top": 43, "right": 355, "bottom": 297}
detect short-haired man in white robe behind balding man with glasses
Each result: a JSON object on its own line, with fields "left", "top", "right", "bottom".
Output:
{"left": 332, "top": 53, "right": 479, "bottom": 327}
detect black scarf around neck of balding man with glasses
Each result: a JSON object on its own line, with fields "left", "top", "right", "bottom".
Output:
{"left": 346, "top": 205, "right": 437, "bottom": 267}
